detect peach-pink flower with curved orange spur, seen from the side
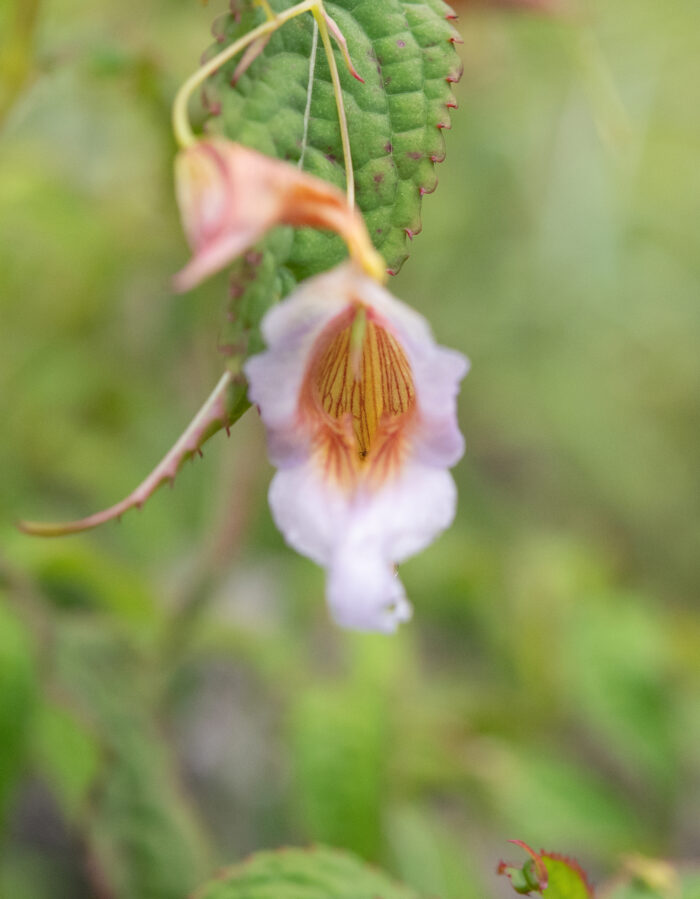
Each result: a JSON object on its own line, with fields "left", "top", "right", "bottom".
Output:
{"left": 174, "top": 138, "right": 384, "bottom": 292}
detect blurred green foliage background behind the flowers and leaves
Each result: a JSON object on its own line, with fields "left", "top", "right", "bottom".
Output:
{"left": 0, "top": 0, "right": 700, "bottom": 899}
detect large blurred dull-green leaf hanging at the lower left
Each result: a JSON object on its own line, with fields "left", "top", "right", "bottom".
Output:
{"left": 51, "top": 622, "right": 208, "bottom": 899}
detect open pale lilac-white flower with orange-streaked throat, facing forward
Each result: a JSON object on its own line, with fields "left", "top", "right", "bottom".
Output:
{"left": 245, "top": 262, "right": 468, "bottom": 632}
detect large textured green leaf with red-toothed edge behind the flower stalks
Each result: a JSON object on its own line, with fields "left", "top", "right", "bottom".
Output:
{"left": 203, "top": 0, "right": 461, "bottom": 362}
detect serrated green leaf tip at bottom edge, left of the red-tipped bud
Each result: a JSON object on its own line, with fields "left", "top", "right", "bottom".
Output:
{"left": 194, "top": 847, "right": 419, "bottom": 899}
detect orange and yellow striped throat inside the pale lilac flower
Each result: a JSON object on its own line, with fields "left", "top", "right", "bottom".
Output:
{"left": 303, "top": 304, "right": 416, "bottom": 485}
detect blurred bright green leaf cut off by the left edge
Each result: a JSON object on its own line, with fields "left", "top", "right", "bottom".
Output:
{"left": 0, "top": 593, "right": 36, "bottom": 823}
